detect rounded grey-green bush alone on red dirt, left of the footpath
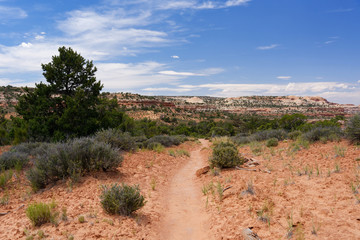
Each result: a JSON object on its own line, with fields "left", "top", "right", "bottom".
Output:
{"left": 100, "top": 184, "right": 145, "bottom": 215}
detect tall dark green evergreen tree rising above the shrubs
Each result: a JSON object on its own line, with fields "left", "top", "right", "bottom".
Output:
{"left": 16, "top": 47, "right": 103, "bottom": 140}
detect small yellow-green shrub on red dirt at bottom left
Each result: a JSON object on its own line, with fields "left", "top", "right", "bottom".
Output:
{"left": 26, "top": 202, "right": 55, "bottom": 227}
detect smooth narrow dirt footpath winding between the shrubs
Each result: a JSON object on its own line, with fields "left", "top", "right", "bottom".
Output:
{"left": 160, "top": 140, "right": 211, "bottom": 240}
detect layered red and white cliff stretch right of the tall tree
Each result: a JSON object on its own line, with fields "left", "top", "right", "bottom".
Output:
{"left": 110, "top": 94, "right": 360, "bottom": 119}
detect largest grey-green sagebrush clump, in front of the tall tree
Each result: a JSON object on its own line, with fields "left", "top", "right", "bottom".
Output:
{"left": 27, "top": 138, "right": 122, "bottom": 190}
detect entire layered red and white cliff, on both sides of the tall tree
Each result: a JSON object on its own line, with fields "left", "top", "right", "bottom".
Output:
{"left": 0, "top": 86, "right": 360, "bottom": 119}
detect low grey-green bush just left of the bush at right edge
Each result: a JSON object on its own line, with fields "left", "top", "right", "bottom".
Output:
{"left": 302, "top": 127, "right": 343, "bottom": 142}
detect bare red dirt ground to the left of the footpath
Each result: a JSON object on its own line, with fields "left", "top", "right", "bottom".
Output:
{"left": 0, "top": 142, "right": 200, "bottom": 239}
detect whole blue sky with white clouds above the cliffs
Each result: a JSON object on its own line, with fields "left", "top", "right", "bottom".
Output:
{"left": 0, "top": 0, "right": 360, "bottom": 104}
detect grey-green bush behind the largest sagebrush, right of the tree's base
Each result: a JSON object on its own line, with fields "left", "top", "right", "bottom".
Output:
{"left": 95, "top": 128, "right": 137, "bottom": 151}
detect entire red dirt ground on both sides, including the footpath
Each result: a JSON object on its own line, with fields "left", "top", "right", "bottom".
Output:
{"left": 0, "top": 141, "right": 360, "bottom": 240}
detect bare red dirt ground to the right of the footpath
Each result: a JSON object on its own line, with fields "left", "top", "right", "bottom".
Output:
{"left": 201, "top": 141, "right": 360, "bottom": 240}
